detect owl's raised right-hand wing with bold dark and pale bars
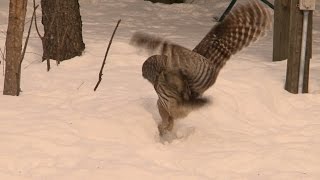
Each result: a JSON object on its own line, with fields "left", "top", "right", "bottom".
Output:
{"left": 193, "top": 0, "right": 272, "bottom": 63}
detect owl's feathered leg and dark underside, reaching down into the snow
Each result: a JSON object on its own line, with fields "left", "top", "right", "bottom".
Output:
{"left": 154, "top": 70, "right": 209, "bottom": 139}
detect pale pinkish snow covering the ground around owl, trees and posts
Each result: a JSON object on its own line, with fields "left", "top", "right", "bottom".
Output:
{"left": 0, "top": 0, "right": 320, "bottom": 180}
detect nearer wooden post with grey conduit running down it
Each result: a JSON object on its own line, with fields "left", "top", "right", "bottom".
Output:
{"left": 285, "top": 0, "right": 312, "bottom": 94}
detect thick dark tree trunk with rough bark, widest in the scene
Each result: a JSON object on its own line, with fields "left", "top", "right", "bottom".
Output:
{"left": 41, "top": 0, "right": 85, "bottom": 62}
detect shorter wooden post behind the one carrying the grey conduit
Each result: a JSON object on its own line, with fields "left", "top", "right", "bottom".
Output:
{"left": 273, "top": 0, "right": 290, "bottom": 61}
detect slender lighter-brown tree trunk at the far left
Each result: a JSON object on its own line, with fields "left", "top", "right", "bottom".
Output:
{"left": 3, "top": 0, "right": 28, "bottom": 96}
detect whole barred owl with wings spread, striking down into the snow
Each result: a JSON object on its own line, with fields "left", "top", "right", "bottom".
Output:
{"left": 130, "top": 0, "right": 271, "bottom": 139}
